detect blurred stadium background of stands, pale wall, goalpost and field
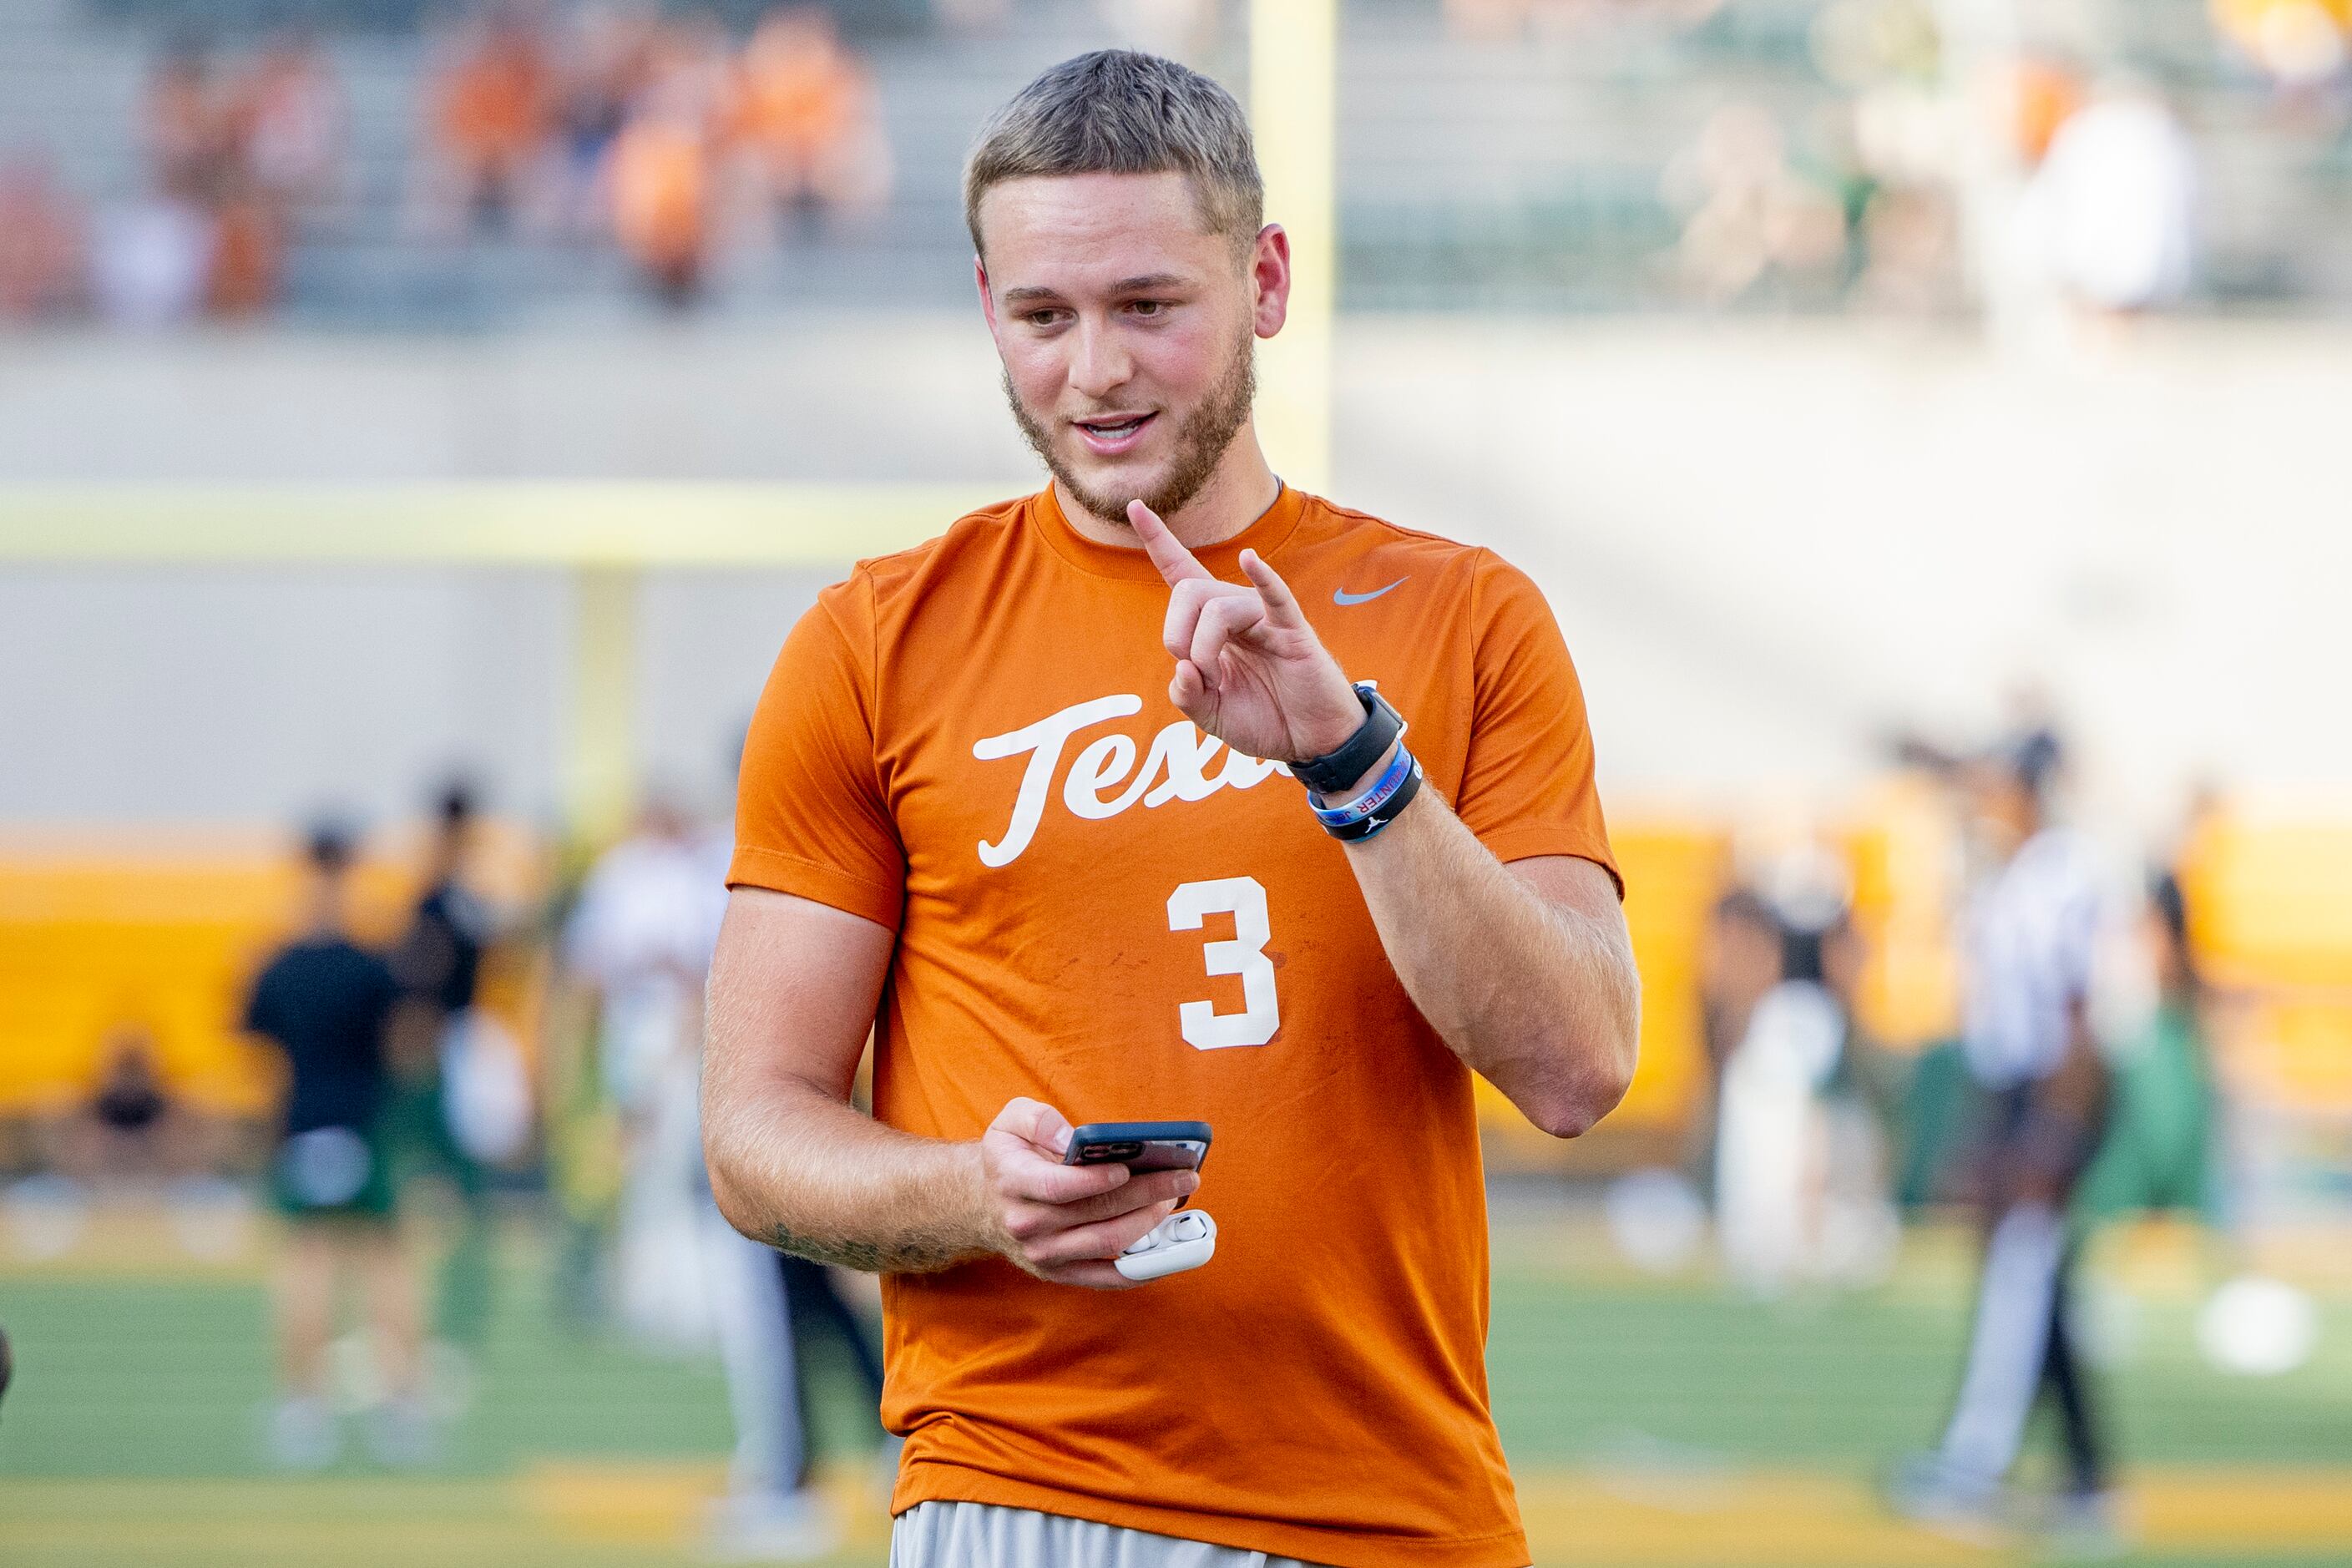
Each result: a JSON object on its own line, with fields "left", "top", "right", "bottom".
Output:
{"left": 0, "top": 0, "right": 2352, "bottom": 1565}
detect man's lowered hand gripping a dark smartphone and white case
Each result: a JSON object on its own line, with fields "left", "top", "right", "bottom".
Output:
{"left": 981, "top": 1100, "right": 1200, "bottom": 1291}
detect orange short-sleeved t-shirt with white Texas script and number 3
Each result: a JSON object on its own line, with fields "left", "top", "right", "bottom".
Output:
{"left": 729, "top": 489, "right": 1613, "bottom": 1568}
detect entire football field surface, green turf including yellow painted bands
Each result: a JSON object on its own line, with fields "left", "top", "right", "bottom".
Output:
{"left": 0, "top": 1216, "right": 2352, "bottom": 1568}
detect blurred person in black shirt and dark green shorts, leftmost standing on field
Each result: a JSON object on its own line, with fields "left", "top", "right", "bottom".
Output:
{"left": 245, "top": 827, "right": 431, "bottom": 1469}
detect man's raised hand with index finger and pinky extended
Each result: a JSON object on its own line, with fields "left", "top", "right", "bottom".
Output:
{"left": 1126, "top": 501, "right": 1364, "bottom": 761}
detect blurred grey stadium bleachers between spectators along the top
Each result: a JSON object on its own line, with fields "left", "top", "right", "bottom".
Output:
{"left": 0, "top": 0, "right": 2352, "bottom": 326}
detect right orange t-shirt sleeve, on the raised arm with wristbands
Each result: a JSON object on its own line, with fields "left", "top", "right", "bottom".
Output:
{"left": 1454, "top": 550, "right": 1626, "bottom": 898}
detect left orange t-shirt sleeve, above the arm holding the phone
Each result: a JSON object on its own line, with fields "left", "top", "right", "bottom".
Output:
{"left": 726, "top": 579, "right": 906, "bottom": 928}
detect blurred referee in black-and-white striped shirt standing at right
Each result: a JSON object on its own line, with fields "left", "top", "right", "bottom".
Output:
{"left": 1894, "top": 731, "right": 2117, "bottom": 1545}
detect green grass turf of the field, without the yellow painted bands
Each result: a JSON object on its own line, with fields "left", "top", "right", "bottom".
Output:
{"left": 0, "top": 1230, "right": 2352, "bottom": 1568}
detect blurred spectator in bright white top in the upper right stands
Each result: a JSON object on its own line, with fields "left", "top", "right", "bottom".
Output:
{"left": 2018, "top": 80, "right": 2197, "bottom": 315}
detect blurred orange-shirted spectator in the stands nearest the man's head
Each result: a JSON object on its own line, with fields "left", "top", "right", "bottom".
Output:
{"left": 731, "top": 5, "right": 892, "bottom": 240}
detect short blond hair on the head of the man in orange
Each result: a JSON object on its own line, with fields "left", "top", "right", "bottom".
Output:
{"left": 964, "top": 49, "right": 1266, "bottom": 254}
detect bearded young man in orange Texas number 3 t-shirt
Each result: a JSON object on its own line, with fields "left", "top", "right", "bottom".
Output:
{"left": 703, "top": 52, "right": 1637, "bottom": 1568}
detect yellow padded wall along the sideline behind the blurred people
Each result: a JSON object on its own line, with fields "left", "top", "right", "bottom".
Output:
{"left": 0, "top": 803, "right": 2352, "bottom": 1133}
